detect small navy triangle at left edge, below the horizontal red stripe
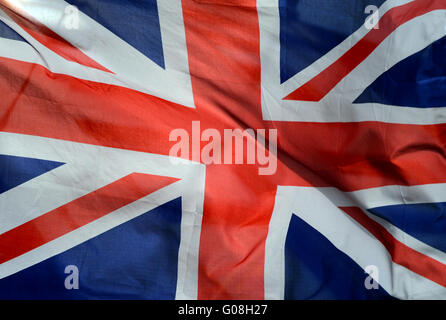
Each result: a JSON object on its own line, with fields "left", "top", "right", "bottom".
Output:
{"left": 0, "top": 154, "right": 63, "bottom": 193}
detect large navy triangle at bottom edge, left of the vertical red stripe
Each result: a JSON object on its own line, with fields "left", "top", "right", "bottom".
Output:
{"left": 0, "top": 198, "right": 181, "bottom": 300}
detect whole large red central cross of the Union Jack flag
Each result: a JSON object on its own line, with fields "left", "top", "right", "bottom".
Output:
{"left": 0, "top": 0, "right": 446, "bottom": 299}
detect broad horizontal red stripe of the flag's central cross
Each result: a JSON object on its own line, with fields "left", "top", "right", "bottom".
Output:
{"left": 0, "top": 57, "right": 446, "bottom": 191}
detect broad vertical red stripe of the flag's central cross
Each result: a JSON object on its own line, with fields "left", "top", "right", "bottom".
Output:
{"left": 182, "top": 0, "right": 268, "bottom": 299}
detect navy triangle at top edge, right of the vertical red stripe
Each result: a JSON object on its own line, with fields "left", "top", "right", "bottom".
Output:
{"left": 279, "top": 0, "right": 385, "bottom": 82}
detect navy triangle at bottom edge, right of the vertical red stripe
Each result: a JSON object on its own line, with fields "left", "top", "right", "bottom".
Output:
{"left": 285, "top": 215, "right": 393, "bottom": 300}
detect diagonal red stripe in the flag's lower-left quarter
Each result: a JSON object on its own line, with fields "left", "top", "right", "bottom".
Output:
{"left": 0, "top": 173, "right": 178, "bottom": 263}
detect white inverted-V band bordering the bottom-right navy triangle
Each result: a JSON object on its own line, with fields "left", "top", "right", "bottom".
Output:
{"left": 265, "top": 187, "right": 446, "bottom": 299}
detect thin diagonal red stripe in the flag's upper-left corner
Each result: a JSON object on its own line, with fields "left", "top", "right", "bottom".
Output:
{"left": 0, "top": 0, "right": 111, "bottom": 72}
